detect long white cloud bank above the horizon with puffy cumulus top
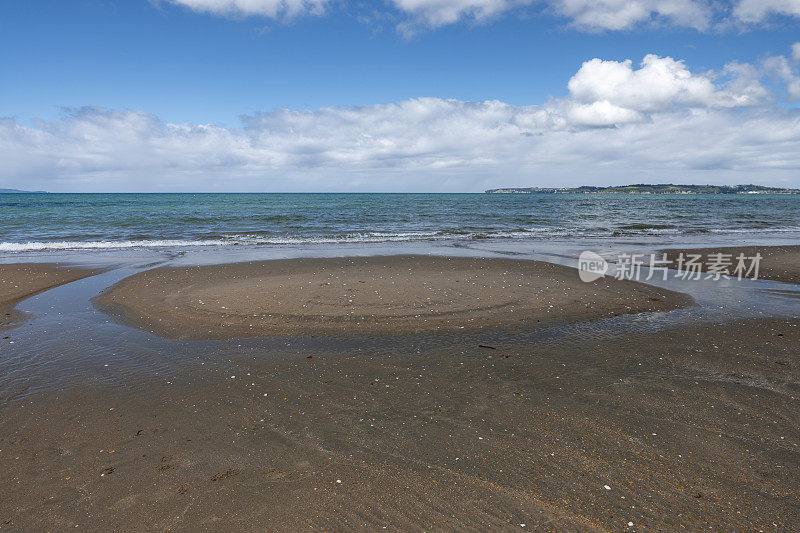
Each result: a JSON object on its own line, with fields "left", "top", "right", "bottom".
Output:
{"left": 0, "top": 56, "right": 800, "bottom": 191}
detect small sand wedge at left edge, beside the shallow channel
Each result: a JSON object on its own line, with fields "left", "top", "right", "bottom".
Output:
{"left": 0, "top": 263, "right": 97, "bottom": 331}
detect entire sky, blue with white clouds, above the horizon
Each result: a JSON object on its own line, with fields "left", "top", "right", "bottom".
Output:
{"left": 0, "top": 0, "right": 800, "bottom": 190}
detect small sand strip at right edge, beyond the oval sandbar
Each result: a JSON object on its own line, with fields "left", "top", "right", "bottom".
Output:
{"left": 662, "top": 246, "right": 800, "bottom": 284}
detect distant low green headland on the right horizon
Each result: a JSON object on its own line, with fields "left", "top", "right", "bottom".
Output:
{"left": 486, "top": 183, "right": 800, "bottom": 194}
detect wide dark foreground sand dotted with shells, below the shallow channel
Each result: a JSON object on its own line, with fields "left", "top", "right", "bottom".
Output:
{"left": 0, "top": 319, "right": 800, "bottom": 531}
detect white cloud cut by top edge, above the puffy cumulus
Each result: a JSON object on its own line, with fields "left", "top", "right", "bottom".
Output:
{"left": 548, "top": 0, "right": 711, "bottom": 30}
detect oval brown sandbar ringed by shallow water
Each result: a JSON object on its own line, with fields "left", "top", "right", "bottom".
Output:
{"left": 95, "top": 255, "right": 692, "bottom": 339}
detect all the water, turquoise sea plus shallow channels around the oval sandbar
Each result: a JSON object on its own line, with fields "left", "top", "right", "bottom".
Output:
{"left": 0, "top": 194, "right": 800, "bottom": 404}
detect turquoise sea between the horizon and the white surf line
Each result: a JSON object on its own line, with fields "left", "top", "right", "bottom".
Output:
{"left": 0, "top": 194, "right": 800, "bottom": 252}
